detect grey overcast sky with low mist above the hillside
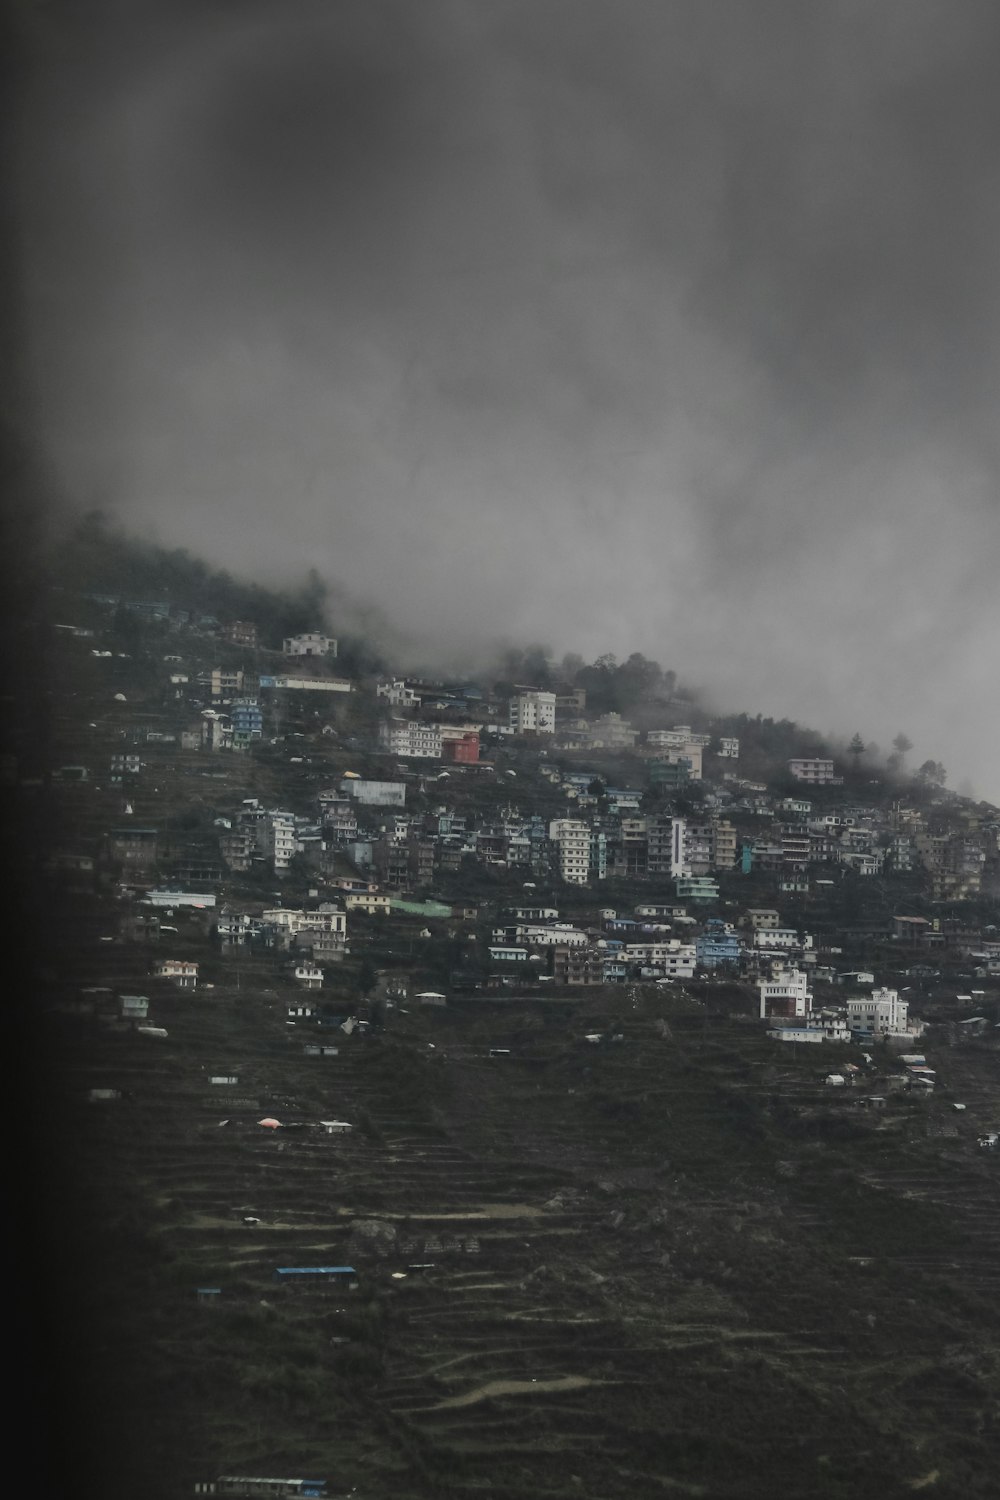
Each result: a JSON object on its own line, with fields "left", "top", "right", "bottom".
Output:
{"left": 18, "top": 0, "right": 1000, "bottom": 801}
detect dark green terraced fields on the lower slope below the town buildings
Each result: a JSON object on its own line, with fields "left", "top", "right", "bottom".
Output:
{"left": 27, "top": 974, "right": 1000, "bottom": 1500}
